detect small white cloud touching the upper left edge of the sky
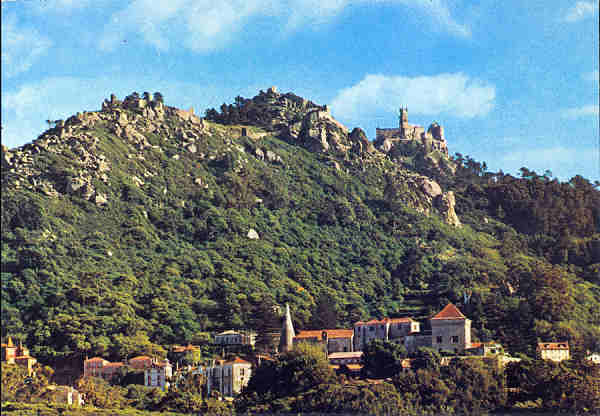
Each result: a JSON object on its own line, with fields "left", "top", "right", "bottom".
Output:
{"left": 2, "top": 13, "right": 52, "bottom": 78}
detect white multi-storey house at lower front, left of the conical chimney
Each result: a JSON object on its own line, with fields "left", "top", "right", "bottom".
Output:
{"left": 206, "top": 357, "right": 252, "bottom": 397}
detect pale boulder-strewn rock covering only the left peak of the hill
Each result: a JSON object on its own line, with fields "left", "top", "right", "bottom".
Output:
{"left": 2, "top": 93, "right": 205, "bottom": 202}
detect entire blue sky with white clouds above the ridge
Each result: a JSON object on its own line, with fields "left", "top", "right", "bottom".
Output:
{"left": 2, "top": 0, "right": 600, "bottom": 180}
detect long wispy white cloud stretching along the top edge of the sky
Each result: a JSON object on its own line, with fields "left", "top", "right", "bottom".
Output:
{"left": 99, "top": 0, "right": 470, "bottom": 52}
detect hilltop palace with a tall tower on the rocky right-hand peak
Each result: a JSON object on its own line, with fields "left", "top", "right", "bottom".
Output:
{"left": 375, "top": 107, "right": 448, "bottom": 156}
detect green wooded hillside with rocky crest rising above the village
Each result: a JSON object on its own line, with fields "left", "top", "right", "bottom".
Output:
{"left": 1, "top": 88, "right": 600, "bottom": 362}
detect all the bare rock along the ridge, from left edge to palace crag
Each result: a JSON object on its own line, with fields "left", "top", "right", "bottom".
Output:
{"left": 1, "top": 88, "right": 460, "bottom": 226}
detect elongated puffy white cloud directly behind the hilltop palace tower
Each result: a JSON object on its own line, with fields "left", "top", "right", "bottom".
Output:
{"left": 331, "top": 73, "right": 496, "bottom": 121}
